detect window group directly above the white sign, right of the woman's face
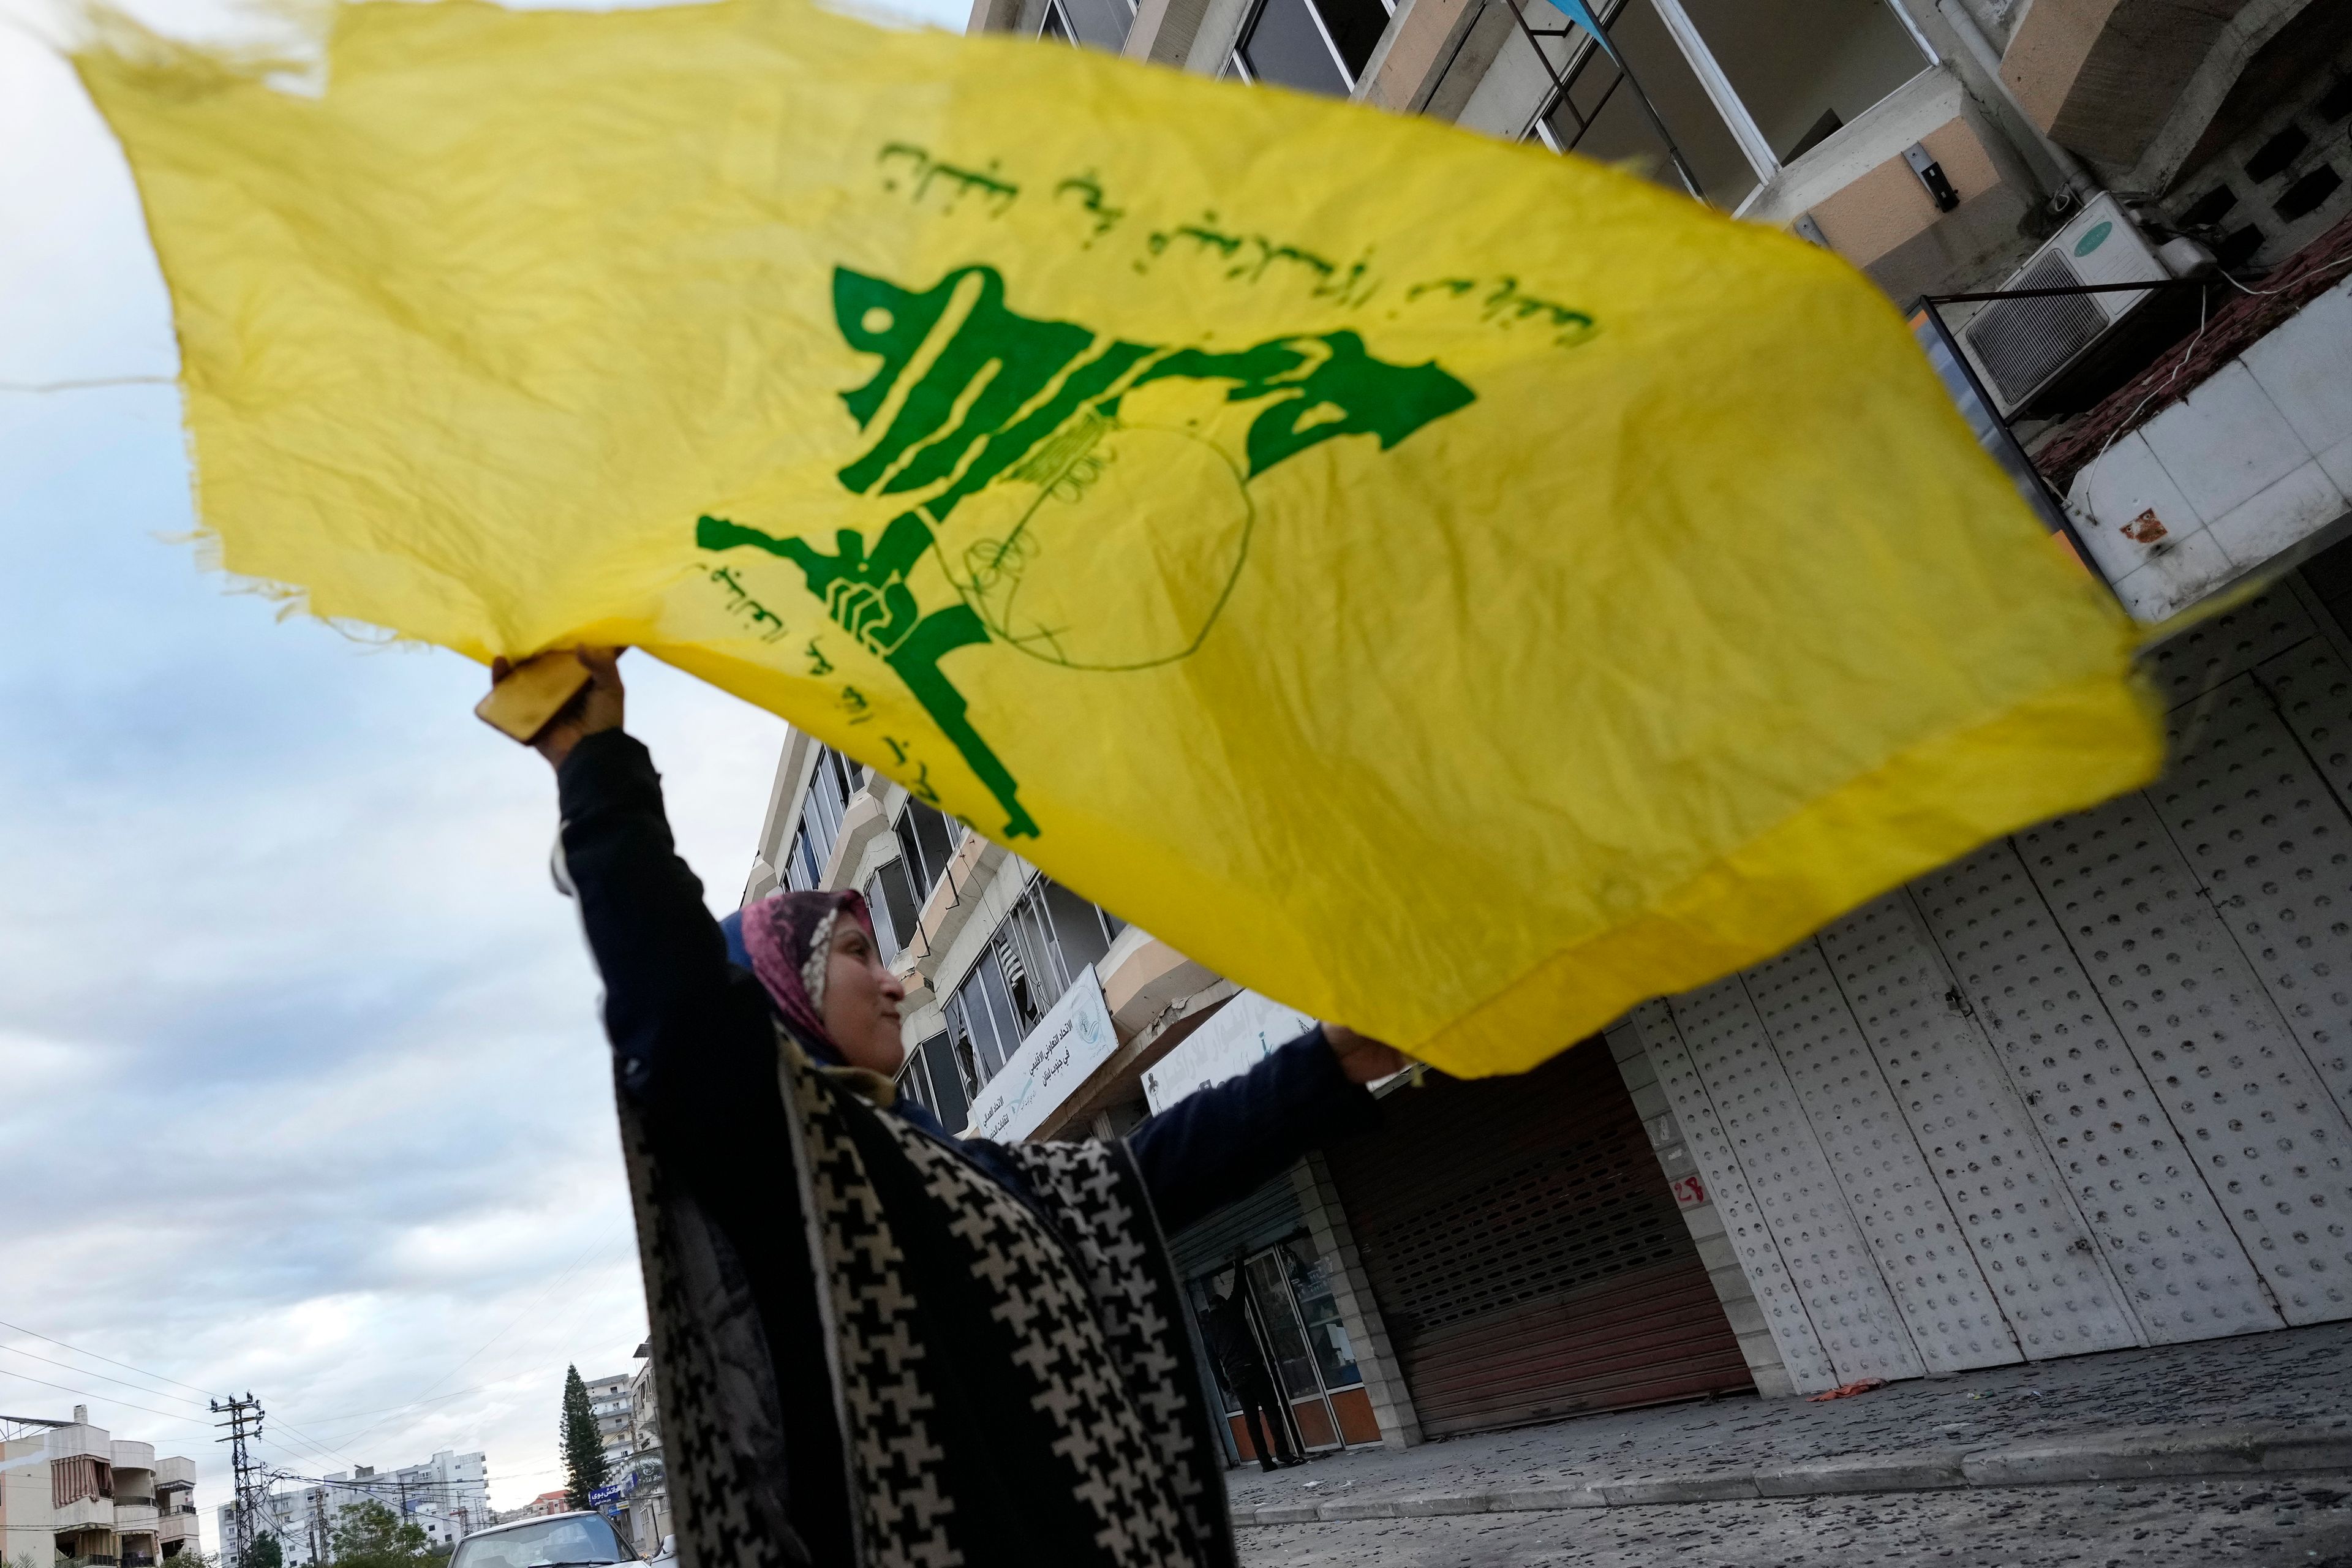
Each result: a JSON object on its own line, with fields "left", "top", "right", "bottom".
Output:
{"left": 943, "top": 877, "right": 1126, "bottom": 1098}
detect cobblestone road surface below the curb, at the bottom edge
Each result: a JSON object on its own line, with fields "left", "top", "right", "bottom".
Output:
{"left": 1240, "top": 1481, "right": 2352, "bottom": 1568}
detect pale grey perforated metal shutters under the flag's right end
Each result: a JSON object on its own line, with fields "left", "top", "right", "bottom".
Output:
{"left": 1637, "top": 581, "right": 2352, "bottom": 1389}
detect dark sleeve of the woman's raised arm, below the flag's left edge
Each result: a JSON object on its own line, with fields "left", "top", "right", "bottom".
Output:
{"left": 555, "top": 729, "right": 762, "bottom": 1110}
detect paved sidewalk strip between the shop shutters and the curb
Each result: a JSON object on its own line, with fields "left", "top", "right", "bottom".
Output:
{"left": 1226, "top": 1324, "right": 2352, "bottom": 1513}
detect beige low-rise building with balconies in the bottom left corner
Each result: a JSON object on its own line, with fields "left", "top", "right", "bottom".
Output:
{"left": 0, "top": 1406, "right": 198, "bottom": 1568}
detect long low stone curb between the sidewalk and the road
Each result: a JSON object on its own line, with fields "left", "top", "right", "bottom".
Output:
{"left": 1232, "top": 1425, "right": 2352, "bottom": 1528}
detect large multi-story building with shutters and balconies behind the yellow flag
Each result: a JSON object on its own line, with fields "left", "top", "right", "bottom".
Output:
{"left": 745, "top": 0, "right": 2352, "bottom": 1455}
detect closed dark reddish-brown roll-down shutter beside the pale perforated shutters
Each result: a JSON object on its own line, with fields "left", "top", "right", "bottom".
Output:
{"left": 1324, "top": 1041, "right": 1752, "bottom": 1436}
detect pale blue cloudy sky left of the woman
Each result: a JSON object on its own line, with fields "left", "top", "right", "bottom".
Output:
{"left": 0, "top": 0, "right": 967, "bottom": 1547}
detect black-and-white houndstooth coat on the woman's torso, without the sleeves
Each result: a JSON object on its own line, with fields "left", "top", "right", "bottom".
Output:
{"left": 621, "top": 1039, "right": 1235, "bottom": 1568}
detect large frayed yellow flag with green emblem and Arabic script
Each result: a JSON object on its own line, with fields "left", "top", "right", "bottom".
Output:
{"left": 78, "top": 0, "right": 2159, "bottom": 1074}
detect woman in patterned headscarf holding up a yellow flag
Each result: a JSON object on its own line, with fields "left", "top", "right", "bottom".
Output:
{"left": 494, "top": 651, "right": 1402, "bottom": 1568}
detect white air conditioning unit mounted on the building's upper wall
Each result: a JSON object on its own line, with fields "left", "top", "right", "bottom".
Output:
{"left": 1959, "top": 193, "right": 2171, "bottom": 416}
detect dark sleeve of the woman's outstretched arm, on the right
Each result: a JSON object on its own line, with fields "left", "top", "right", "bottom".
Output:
{"left": 1126, "top": 1030, "right": 1378, "bottom": 1237}
